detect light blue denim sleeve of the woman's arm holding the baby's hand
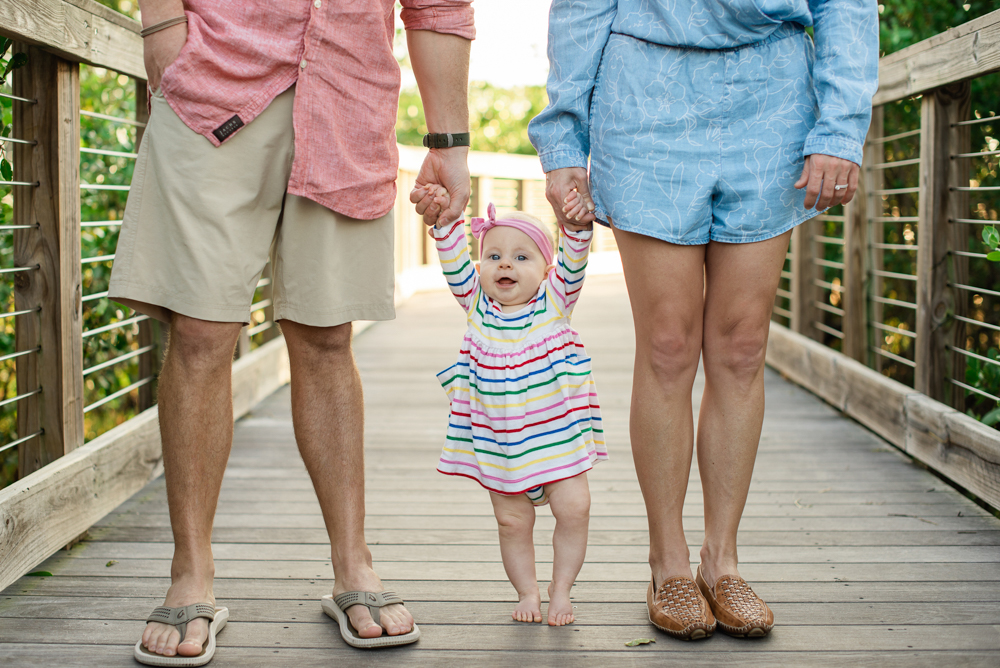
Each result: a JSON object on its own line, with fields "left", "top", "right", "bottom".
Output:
{"left": 528, "top": 0, "right": 618, "bottom": 172}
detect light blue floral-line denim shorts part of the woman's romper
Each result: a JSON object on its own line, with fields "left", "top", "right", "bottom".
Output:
{"left": 590, "top": 23, "right": 821, "bottom": 245}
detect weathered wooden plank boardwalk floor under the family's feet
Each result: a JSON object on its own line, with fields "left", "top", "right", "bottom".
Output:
{"left": 0, "top": 276, "right": 1000, "bottom": 668}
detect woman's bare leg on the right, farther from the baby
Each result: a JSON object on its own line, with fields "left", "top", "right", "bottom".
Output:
{"left": 698, "top": 232, "right": 791, "bottom": 587}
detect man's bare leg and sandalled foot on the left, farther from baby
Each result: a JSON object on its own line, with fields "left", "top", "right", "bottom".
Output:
{"left": 142, "top": 315, "right": 241, "bottom": 656}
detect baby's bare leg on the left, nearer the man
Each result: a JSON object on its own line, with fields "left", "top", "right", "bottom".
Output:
{"left": 490, "top": 492, "right": 542, "bottom": 622}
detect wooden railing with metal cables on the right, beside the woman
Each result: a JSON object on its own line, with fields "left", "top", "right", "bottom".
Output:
{"left": 768, "top": 11, "right": 1000, "bottom": 507}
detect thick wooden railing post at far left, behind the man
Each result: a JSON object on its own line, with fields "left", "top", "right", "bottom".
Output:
{"left": 14, "top": 47, "right": 84, "bottom": 476}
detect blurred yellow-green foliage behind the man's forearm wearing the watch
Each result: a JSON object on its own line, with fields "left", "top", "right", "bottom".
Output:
{"left": 396, "top": 82, "right": 548, "bottom": 155}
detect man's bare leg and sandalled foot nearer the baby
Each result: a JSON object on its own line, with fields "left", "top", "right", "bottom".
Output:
{"left": 281, "top": 320, "right": 413, "bottom": 638}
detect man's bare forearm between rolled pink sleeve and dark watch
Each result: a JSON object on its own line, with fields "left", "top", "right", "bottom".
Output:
{"left": 406, "top": 30, "right": 472, "bottom": 133}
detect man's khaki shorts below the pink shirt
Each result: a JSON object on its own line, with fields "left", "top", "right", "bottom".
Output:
{"left": 109, "top": 87, "right": 395, "bottom": 327}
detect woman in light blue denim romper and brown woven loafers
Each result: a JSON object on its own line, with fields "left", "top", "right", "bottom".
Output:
{"left": 529, "top": 0, "right": 878, "bottom": 639}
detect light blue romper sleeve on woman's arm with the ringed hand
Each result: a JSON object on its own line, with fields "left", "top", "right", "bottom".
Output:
{"left": 803, "top": 0, "right": 878, "bottom": 165}
